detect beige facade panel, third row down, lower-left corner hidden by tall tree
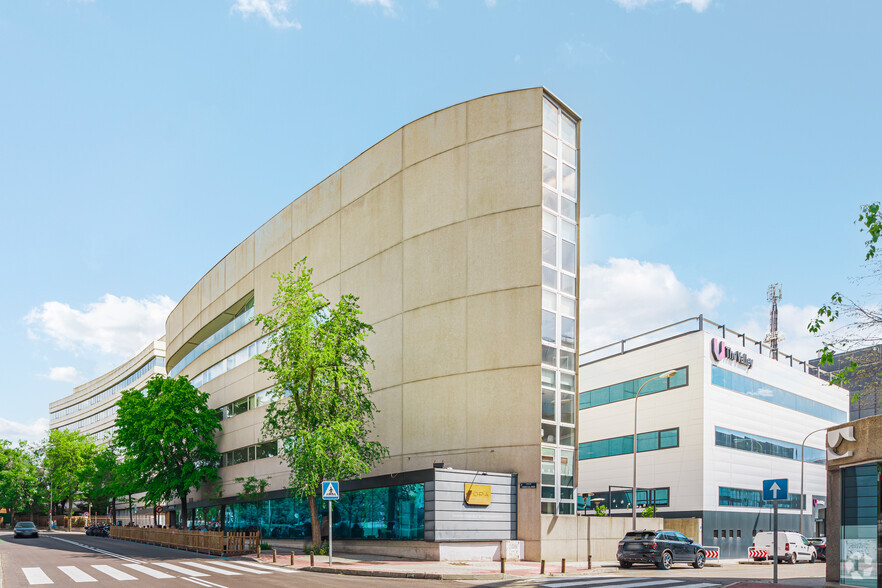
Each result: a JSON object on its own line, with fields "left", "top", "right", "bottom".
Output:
{"left": 340, "top": 245, "right": 402, "bottom": 324}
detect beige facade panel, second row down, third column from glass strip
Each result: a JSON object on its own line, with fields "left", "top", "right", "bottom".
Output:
{"left": 340, "top": 174, "right": 402, "bottom": 269}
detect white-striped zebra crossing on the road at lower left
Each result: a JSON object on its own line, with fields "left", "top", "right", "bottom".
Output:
{"left": 21, "top": 560, "right": 297, "bottom": 586}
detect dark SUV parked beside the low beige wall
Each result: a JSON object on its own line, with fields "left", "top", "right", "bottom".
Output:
{"left": 616, "top": 530, "right": 705, "bottom": 570}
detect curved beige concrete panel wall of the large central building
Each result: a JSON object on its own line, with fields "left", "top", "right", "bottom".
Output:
{"left": 166, "top": 88, "right": 578, "bottom": 552}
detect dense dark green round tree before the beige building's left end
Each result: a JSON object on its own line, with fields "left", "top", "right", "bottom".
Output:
{"left": 114, "top": 376, "right": 220, "bottom": 525}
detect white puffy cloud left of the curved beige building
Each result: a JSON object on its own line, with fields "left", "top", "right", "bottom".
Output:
{"left": 24, "top": 294, "right": 175, "bottom": 358}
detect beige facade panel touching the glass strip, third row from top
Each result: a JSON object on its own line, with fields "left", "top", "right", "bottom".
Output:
{"left": 468, "top": 206, "right": 542, "bottom": 296}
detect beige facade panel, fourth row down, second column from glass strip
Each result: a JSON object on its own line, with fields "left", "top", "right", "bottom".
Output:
{"left": 403, "top": 299, "right": 466, "bottom": 382}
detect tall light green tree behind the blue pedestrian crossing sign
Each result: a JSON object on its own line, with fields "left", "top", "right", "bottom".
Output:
{"left": 256, "top": 259, "right": 388, "bottom": 545}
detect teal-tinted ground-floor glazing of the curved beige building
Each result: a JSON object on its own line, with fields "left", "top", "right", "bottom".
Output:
{"left": 188, "top": 484, "right": 425, "bottom": 540}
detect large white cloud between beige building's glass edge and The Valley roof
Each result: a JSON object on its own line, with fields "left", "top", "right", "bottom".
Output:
{"left": 579, "top": 258, "right": 723, "bottom": 352}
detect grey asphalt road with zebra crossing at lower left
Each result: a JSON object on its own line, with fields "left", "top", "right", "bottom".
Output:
{"left": 0, "top": 532, "right": 449, "bottom": 588}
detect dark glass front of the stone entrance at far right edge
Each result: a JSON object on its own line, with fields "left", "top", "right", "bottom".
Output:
{"left": 839, "top": 463, "right": 882, "bottom": 588}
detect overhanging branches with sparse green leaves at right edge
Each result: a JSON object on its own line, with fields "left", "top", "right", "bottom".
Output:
{"left": 808, "top": 202, "right": 882, "bottom": 390}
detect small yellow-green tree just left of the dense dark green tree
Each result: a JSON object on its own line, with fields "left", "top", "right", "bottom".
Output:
{"left": 43, "top": 429, "right": 96, "bottom": 531}
